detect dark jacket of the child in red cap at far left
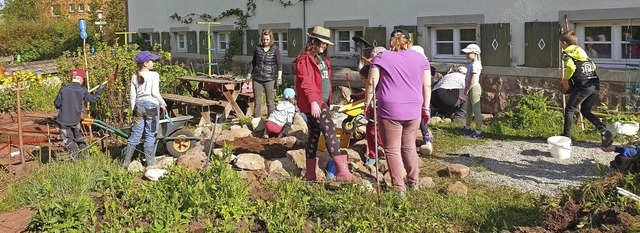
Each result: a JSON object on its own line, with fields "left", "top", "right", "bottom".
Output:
{"left": 53, "top": 82, "right": 103, "bottom": 126}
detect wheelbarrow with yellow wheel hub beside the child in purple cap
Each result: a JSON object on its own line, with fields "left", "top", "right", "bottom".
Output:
{"left": 82, "top": 116, "right": 200, "bottom": 158}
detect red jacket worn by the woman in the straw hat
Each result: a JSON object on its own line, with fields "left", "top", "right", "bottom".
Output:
{"left": 296, "top": 53, "right": 333, "bottom": 113}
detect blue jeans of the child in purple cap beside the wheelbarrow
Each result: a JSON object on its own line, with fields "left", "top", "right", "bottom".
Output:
{"left": 127, "top": 101, "right": 160, "bottom": 148}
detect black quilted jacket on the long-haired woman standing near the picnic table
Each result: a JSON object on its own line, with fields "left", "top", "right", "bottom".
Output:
{"left": 250, "top": 45, "right": 282, "bottom": 82}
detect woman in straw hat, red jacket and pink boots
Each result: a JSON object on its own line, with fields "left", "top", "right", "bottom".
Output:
{"left": 296, "top": 26, "right": 353, "bottom": 181}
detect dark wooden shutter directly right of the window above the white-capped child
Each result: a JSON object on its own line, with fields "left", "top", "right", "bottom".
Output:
{"left": 480, "top": 23, "right": 511, "bottom": 66}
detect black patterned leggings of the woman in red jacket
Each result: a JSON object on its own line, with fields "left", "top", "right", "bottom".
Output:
{"left": 305, "top": 104, "right": 340, "bottom": 159}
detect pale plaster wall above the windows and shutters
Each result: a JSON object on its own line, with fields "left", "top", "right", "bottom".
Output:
{"left": 129, "top": 0, "right": 640, "bottom": 64}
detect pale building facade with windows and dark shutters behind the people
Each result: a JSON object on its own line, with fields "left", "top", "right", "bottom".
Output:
{"left": 128, "top": 0, "right": 640, "bottom": 111}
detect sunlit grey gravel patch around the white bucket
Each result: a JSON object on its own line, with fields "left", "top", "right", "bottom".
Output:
{"left": 440, "top": 140, "right": 615, "bottom": 195}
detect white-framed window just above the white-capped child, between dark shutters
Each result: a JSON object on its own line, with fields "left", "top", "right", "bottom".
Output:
{"left": 431, "top": 28, "right": 476, "bottom": 59}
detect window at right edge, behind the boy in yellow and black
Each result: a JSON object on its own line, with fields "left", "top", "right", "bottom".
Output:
{"left": 576, "top": 20, "right": 640, "bottom": 68}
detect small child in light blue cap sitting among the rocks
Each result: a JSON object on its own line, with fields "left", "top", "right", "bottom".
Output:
{"left": 262, "top": 88, "right": 296, "bottom": 138}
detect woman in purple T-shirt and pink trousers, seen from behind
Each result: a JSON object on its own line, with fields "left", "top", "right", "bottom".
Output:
{"left": 365, "top": 33, "right": 431, "bottom": 196}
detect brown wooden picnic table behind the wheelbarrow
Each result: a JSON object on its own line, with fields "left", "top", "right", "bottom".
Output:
{"left": 176, "top": 75, "right": 254, "bottom": 119}
